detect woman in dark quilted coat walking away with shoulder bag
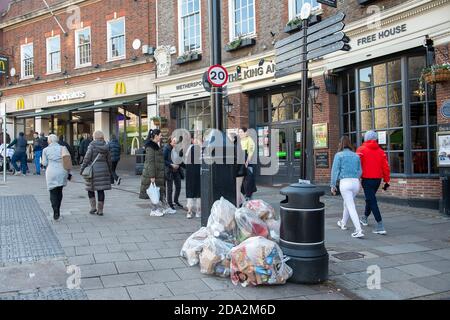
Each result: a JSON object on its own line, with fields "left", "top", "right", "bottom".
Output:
{"left": 80, "top": 131, "right": 112, "bottom": 216}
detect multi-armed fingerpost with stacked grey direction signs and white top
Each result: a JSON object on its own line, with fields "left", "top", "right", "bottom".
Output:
{"left": 275, "top": 5, "right": 351, "bottom": 179}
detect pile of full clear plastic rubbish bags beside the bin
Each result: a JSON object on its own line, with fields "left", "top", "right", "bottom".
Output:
{"left": 180, "top": 197, "right": 292, "bottom": 287}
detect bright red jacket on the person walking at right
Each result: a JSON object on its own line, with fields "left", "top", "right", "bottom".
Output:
{"left": 356, "top": 140, "right": 391, "bottom": 183}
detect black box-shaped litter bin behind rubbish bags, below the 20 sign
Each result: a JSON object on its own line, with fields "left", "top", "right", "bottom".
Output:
{"left": 200, "top": 129, "right": 236, "bottom": 226}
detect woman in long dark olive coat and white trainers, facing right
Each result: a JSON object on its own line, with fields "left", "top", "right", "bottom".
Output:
{"left": 139, "top": 129, "right": 176, "bottom": 217}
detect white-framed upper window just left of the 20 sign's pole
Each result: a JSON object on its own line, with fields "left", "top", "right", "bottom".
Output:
{"left": 178, "top": 0, "right": 201, "bottom": 53}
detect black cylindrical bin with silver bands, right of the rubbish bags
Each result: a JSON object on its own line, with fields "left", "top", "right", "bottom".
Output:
{"left": 280, "top": 183, "right": 328, "bottom": 284}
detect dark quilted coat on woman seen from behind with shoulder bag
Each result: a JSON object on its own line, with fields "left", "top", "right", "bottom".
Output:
{"left": 81, "top": 140, "right": 112, "bottom": 191}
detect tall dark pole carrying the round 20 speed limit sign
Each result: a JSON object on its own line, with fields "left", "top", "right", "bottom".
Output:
{"left": 209, "top": 0, "right": 223, "bottom": 131}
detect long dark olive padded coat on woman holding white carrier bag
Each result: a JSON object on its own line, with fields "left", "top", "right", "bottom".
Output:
{"left": 140, "top": 141, "right": 166, "bottom": 198}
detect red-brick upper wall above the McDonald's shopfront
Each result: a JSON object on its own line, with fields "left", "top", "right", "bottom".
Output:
{"left": 1, "top": 0, "right": 156, "bottom": 92}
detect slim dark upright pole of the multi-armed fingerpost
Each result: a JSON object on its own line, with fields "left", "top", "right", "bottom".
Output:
{"left": 300, "top": 19, "right": 308, "bottom": 179}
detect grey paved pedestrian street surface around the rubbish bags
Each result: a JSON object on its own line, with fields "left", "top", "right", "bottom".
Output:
{"left": 0, "top": 168, "right": 450, "bottom": 300}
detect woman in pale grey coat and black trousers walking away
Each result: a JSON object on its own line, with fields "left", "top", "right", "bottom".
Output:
{"left": 42, "top": 134, "right": 72, "bottom": 220}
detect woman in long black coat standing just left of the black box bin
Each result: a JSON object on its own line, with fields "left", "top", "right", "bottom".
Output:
{"left": 184, "top": 136, "right": 202, "bottom": 219}
